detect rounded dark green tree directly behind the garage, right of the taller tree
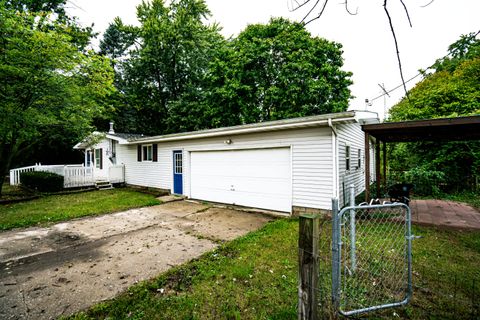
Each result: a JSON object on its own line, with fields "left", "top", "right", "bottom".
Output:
{"left": 209, "top": 18, "right": 352, "bottom": 123}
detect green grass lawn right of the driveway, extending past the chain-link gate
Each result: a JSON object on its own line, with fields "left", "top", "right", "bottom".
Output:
{"left": 71, "top": 219, "right": 480, "bottom": 319}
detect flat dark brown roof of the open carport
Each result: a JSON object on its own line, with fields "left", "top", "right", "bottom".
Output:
{"left": 362, "top": 115, "right": 480, "bottom": 142}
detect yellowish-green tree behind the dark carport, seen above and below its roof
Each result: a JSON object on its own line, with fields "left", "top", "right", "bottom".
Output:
{"left": 390, "top": 33, "right": 480, "bottom": 191}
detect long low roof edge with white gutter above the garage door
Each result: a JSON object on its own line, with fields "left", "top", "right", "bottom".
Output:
{"left": 128, "top": 111, "right": 378, "bottom": 144}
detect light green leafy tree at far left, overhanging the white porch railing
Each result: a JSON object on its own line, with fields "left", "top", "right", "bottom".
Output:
{"left": 0, "top": 2, "right": 113, "bottom": 194}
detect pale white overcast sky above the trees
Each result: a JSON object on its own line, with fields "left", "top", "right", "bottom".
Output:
{"left": 67, "top": 0, "right": 480, "bottom": 118}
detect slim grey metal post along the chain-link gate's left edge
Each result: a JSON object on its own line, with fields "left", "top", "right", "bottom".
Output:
{"left": 332, "top": 198, "right": 340, "bottom": 312}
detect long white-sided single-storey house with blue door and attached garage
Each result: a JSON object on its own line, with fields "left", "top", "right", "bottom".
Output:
{"left": 75, "top": 111, "right": 378, "bottom": 213}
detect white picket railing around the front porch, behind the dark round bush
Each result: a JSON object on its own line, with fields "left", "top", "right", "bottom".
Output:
{"left": 10, "top": 164, "right": 125, "bottom": 188}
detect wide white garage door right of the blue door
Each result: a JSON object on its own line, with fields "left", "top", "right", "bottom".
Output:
{"left": 190, "top": 148, "right": 292, "bottom": 212}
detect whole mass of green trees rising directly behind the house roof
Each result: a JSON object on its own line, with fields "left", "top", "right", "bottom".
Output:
{"left": 101, "top": 5, "right": 352, "bottom": 134}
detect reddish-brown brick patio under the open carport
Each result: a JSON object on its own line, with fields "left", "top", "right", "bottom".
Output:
{"left": 410, "top": 200, "right": 480, "bottom": 230}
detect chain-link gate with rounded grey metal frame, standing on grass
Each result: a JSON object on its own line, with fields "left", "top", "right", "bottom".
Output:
{"left": 332, "top": 202, "right": 413, "bottom": 316}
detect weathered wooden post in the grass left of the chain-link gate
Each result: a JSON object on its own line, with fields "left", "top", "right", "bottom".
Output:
{"left": 298, "top": 215, "right": 320, "bottom": 320}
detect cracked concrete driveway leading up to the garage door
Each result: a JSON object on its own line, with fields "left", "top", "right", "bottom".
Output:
{"left": 0, "top": 201, "right": 271, "bottom": 319}
